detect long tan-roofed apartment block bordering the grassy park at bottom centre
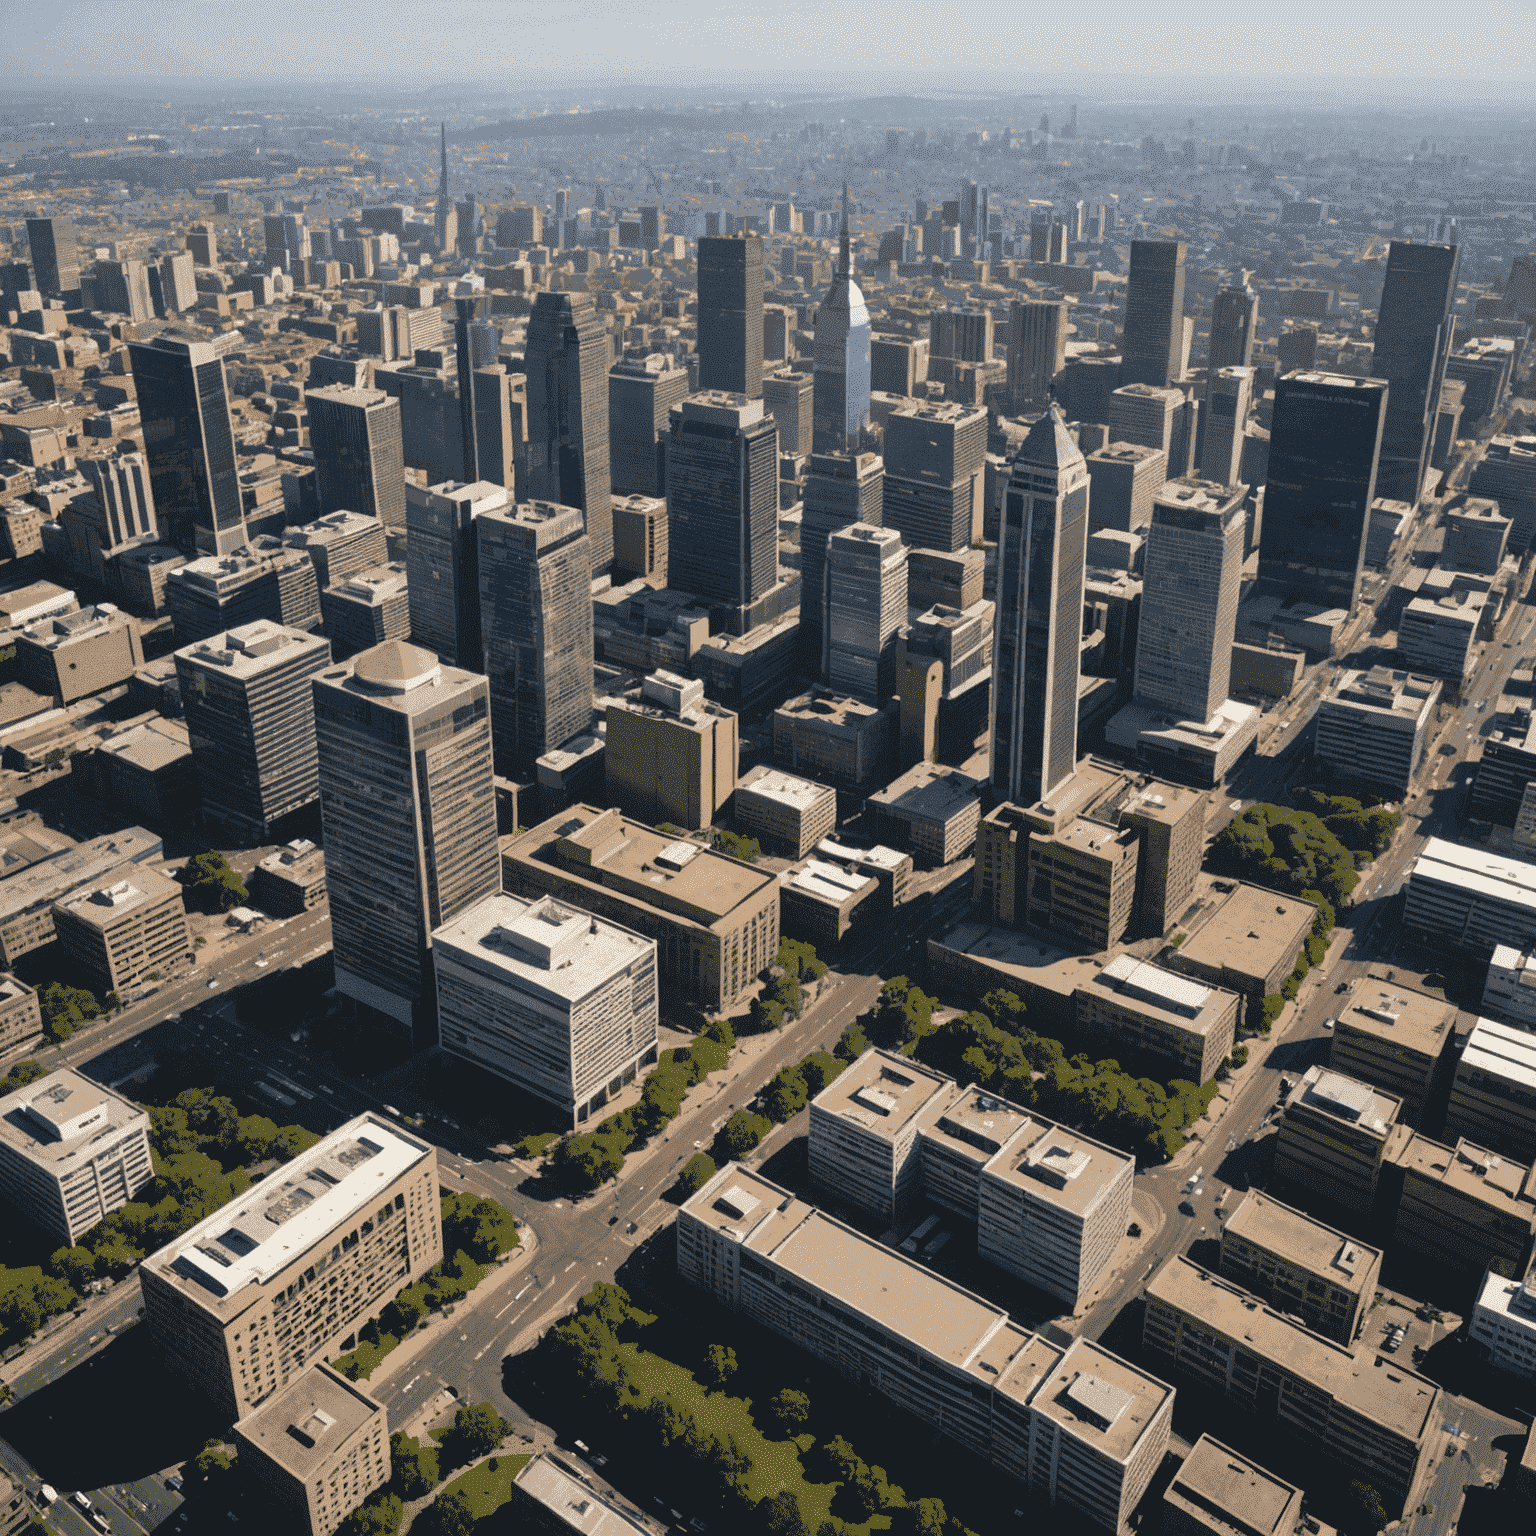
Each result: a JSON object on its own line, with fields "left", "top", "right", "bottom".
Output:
{"left": 677, "top": 1163, "right": 1174, "bottom": 1533}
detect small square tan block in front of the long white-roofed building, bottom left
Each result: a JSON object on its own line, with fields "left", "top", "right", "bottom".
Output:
{"left": 233, "top": 1361, "right": 390, "bottom": 1536}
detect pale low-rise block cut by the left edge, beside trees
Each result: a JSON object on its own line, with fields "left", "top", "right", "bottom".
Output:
{"left": 0, "top": 1066, "right": 155, "bottom": 1247}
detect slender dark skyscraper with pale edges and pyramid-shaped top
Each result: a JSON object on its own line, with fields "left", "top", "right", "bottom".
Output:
{"left": 991, "top": 406, "right": 1087, "bottom": 805}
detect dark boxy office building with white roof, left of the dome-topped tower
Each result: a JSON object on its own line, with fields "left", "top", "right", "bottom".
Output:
{"left": 175, "top": 619, "right": 330, "bottom": 842}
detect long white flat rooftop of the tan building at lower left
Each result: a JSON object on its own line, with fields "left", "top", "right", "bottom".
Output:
{"left": 144, "top": 1114, "right": 435, "bottom": 1318}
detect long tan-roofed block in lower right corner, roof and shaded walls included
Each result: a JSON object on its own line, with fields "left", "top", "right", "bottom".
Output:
{"left": 1143, "top": 1256, "right": 1444, "bottom": 1511}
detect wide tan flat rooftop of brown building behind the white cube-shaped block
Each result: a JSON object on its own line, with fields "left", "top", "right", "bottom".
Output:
{"left": 502, "top": 805, "right": 777, "bottom": 925}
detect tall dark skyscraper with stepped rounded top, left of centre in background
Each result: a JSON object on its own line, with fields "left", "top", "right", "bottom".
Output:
{"left": 524, "top": 293, "right": 611, "bottom": 576}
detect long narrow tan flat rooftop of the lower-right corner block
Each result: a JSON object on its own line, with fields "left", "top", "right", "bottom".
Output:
{"left": 1146, "top": 1255, "right": 1441, "bottom": 1442}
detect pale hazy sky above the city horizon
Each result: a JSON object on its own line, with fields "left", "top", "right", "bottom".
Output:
{"left": 0, "top": 0, "right": 1536, "bottom": 97}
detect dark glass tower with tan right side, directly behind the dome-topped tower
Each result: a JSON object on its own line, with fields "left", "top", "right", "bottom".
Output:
{"left": 475, "top": 501, "right": 593, "bottom": 783}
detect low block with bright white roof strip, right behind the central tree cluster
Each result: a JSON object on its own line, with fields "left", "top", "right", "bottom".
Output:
{"left": 1072, "top": 952, "right": 1243, "bottom": 1083}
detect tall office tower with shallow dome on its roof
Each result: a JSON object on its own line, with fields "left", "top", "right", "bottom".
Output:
{"left": 313, "top": 641, "right": 501, "bottom": 1031}
